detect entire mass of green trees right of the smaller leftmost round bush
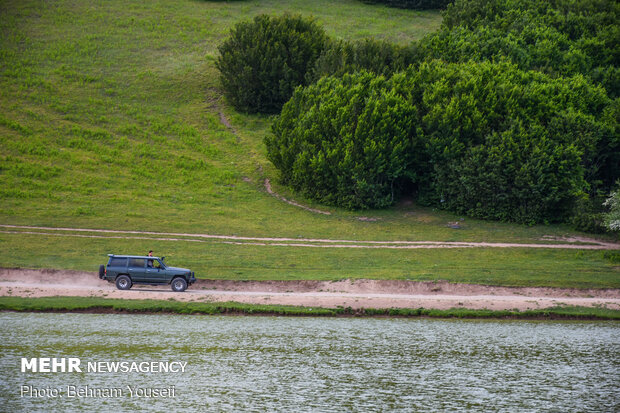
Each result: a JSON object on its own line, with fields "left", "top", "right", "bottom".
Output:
{"left": 239, "top": 0, "right": 620, "bottom": 229}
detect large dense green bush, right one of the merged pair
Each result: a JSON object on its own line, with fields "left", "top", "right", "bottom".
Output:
{"left": 392, "top": 61, "right": 613, "bottom": 223}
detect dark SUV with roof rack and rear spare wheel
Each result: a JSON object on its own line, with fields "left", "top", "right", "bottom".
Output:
{"left": 99, "top": 254, "right": 196, "bottom": 291}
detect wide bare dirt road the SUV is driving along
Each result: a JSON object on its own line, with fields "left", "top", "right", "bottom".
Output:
{"left": 0, "top": 269, "right": 620, "bottom": 311}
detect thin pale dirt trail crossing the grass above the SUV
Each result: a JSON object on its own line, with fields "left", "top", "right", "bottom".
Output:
{"left": 0, "top": 224, "right": 620, "bottom": 250}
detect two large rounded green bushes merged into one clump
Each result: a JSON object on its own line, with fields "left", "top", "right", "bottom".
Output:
{"left": 266, "top": 61, "right": 617, "bottom": 224}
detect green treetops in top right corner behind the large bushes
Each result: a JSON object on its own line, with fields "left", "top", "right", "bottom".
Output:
{"left": 420, "top": 0, "right": 620, "bottom": 97}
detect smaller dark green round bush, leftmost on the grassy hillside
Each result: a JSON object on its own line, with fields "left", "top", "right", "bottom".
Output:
{"left": 216, "top": 14, "right": 327, "bottom": 113}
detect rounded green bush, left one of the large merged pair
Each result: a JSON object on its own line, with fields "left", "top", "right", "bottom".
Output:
{"left": 265, "top": 72, "right": 416, "bottom": 208}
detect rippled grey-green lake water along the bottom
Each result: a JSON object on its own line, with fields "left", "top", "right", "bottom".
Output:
{"left": 0, "top": 313, "right": 620, "bottom": 412}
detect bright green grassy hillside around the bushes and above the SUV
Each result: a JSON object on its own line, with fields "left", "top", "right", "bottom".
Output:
{"left": 0, "top": 0, "right": 620, "bottom": 288}
